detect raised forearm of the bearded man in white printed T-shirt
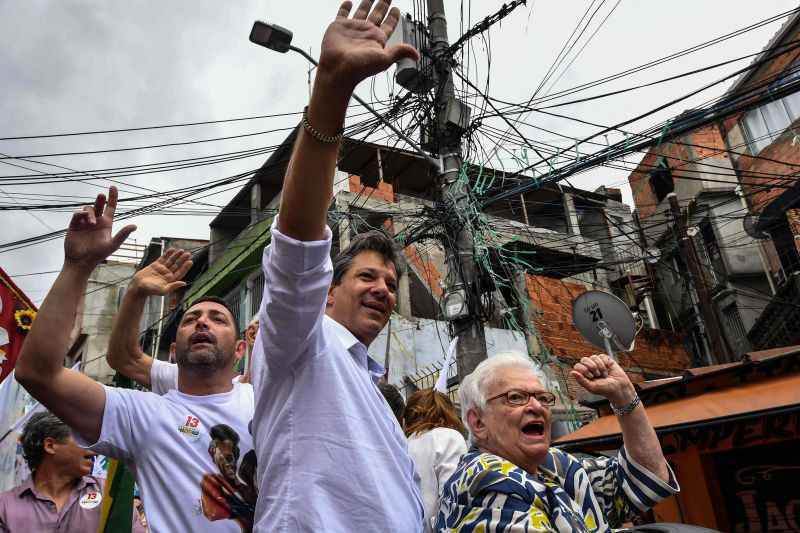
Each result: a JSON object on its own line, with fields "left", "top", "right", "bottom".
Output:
{"left": 15, "top": 264, "right": 91, "bottom": 382}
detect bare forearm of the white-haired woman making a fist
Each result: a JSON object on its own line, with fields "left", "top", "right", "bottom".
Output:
{"left": 612, "top": 387, "right": 669, "bottom": 481}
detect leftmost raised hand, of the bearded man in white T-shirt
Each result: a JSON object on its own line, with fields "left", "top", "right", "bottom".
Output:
{"left": 64, "top": 187, "right": 136, "bottom": 271}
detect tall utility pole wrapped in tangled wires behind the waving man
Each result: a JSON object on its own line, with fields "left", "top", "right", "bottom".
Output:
{"left": 427, "top": 0, "right": 487, "bottom": 378}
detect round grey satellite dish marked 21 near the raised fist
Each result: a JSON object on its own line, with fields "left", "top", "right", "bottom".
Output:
{"left": 572, "top": 291, "right": 636, "bottom": 360}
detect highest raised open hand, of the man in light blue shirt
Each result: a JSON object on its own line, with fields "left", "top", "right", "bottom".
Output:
{"left": 319, "top": 0, "right": 419, "bottom": 92}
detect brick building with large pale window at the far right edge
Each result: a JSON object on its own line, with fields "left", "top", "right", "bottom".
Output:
{"left": 719, "top": 14, "right": 800, "bottom": 349}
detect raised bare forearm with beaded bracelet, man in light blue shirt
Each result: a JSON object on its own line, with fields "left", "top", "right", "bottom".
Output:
{"left": 278, "top": 71, "right": 352, "bottom": 241}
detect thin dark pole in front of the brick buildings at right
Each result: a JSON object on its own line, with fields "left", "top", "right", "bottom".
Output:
{"left": 667, "top": 192, "right": 728, "bottom": 365}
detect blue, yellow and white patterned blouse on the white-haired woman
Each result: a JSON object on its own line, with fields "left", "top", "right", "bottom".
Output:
{"left": 436, "top": 447, "right": 680, "bottom": 533}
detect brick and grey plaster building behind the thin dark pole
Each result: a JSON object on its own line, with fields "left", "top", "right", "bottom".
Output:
{"left": 628, "top": 117, "right": 771, "bottom": 365}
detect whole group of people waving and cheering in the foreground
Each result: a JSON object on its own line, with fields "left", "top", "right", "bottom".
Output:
{"left": 0, "top": 0, "right": 679, "bottom": 533}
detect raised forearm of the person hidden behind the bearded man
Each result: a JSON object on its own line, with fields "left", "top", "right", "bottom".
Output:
{"left": 107, "top": 287, "right": 153, "bottom": 386}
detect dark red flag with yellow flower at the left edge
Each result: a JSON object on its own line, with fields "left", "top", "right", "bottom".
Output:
{"left": 0, "top": 268, "right": 36, "bottom": 383}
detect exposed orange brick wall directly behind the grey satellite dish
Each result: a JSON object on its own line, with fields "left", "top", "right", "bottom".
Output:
{"left": 526, "top": 275, "right": 691, "bottom": 398}
